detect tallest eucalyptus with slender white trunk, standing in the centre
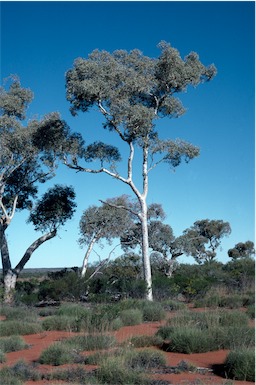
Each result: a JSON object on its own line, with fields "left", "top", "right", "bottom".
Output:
{"left": 64, "top": 42, "right": 216, "bottom": 300}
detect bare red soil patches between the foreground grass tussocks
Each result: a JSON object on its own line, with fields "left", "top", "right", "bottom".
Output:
{"left": 0, "top": 309, "right": 255, "bottom": 385}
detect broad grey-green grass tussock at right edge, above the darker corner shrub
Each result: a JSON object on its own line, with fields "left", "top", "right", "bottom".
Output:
{"left": 157, "top": 310, "right": 255, "bottom": 354}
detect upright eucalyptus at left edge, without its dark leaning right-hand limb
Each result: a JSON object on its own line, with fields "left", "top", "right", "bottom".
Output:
{"left": 0, "top": 77, "right": 75, "bottom": 300}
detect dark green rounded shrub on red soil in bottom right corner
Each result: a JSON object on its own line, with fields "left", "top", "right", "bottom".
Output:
{"left": 225, "top": 349, "right": 255, "bottom": 382}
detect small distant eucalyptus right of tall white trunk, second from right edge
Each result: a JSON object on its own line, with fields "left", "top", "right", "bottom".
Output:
{"left": 180, "top": 219, "right": 231, "bottom": 264}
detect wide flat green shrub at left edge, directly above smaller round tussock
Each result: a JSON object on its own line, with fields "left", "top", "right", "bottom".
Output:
{"left": 0, "top": 320, "right": 42, "bottom": 336}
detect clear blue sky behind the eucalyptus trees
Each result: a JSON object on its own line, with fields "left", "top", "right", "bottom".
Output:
{"left": 0, "top": 1, "right": 255, "bottom": 267}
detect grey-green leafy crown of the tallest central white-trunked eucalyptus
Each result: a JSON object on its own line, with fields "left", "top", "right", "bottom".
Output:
{"left": 66, "top": 42, "right": 216, "bottom": 161}
